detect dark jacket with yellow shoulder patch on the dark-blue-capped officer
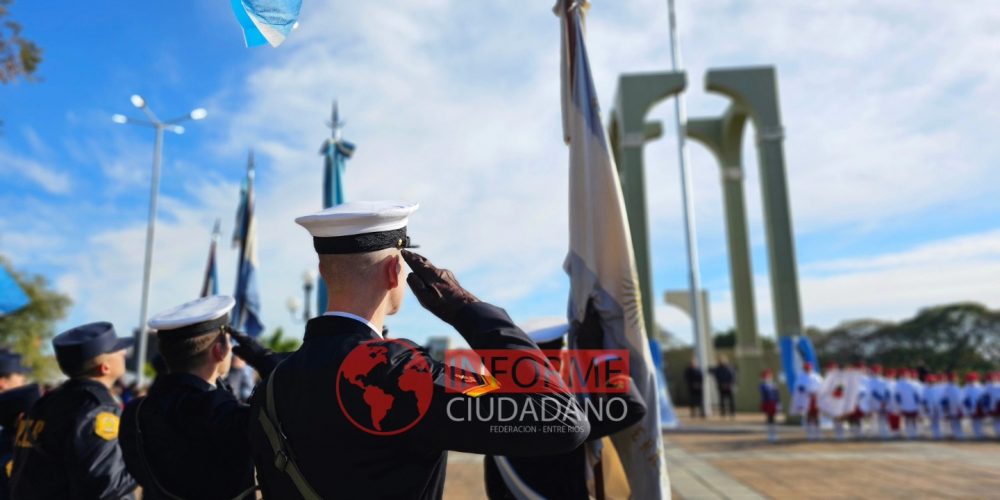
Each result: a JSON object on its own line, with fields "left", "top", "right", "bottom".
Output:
{"left": 11, "top": 379, "right": 136, "bottom": 500}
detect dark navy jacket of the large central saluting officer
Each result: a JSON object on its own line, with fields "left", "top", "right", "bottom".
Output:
{"left": 250, "top": 303, "right": 590, "bottom": 500}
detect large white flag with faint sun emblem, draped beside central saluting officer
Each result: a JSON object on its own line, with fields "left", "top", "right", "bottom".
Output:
{"left": 556, "top": 0, "right": 670, "bottom": 499}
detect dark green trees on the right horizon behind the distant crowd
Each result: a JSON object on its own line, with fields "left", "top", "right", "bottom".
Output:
{"left": 809, "top": 303, "right": 1000, "bottom": 371}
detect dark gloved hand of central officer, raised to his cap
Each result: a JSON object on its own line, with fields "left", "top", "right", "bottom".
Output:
{"left": 402, "top": 250, "right": 479, "bottom": 323}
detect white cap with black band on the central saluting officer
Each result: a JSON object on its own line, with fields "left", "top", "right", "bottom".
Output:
{"left": 295, "top": 201, "right": 420, "bottom": 254}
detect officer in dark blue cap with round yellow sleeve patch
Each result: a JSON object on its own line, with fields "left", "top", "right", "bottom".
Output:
{"left": 11, "top": 322, "right": 136, "bottom": 500}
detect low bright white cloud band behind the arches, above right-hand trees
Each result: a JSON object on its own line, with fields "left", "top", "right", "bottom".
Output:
{"left": 657, "top": 231, "right": 1000, "bottom": 341}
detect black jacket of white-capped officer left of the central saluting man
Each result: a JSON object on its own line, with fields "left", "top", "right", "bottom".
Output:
{"left": 121, "top": 373, "right": 254, "bottom": 500}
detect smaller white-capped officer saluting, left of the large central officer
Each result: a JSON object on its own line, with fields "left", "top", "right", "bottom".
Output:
{"left": 121, "top": 296, "right": 277, "bottom": 500}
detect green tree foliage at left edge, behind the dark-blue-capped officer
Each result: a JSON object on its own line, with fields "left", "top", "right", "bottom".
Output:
{"left": 0, "top": 257, "right": 71, "bottom": 381}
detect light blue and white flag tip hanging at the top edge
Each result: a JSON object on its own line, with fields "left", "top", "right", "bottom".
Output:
{"left": 232, "top": 0, "right": 302, "bottom": 47}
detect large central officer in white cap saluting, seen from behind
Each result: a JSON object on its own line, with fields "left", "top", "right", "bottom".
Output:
{"left": 250, "top": 202, "right": 590, "bottom": 499}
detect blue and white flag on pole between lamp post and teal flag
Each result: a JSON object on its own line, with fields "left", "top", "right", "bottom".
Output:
{"left": 232, "top": 151, "right": 264, "bottom": 337}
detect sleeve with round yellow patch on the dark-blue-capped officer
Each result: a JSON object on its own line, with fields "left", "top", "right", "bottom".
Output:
{"left": 66, "top": 405, "right": 136, "bottom": 500}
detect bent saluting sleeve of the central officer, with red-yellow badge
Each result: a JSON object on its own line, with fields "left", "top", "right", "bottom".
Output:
{"left": 390, "top": 302, "right": 590, "bottom": 456}
